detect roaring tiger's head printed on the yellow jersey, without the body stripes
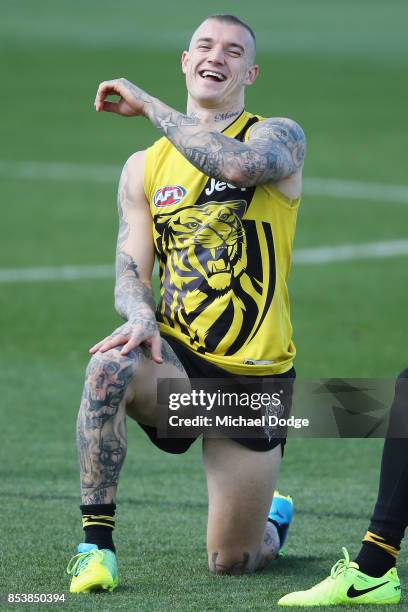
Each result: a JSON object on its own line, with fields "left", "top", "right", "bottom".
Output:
{"left": 155, "top": 200, "right": 247, "bottom": 298}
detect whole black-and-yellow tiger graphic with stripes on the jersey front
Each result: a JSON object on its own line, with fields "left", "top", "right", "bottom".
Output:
{"left": 154, "top": 200, "right": 275, "bottom": 355}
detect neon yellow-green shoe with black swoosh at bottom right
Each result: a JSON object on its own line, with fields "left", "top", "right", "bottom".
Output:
{"left": 278, "top": 548, "right": 401, "bottom": 607}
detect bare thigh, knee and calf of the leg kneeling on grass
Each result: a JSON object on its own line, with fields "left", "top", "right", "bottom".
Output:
{"left": 203, "top": 438, "right": 281, "bottom": 575}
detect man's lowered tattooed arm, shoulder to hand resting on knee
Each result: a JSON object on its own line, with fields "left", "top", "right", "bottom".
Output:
{"left": 91, "top": 151, "right": 162, "bottom": 363}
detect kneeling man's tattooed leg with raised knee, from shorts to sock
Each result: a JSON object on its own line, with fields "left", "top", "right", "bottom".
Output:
{"left": 77, "top": 339, "right": 187, "bottom": 504}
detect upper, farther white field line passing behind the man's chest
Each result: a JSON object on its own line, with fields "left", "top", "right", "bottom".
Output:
{"left": 0, "top": 160, "right": 408, "bottom": 204}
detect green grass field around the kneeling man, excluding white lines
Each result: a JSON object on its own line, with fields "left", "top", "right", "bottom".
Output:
{"left": 0, "top": 0, "right": 408, "bottom": 612}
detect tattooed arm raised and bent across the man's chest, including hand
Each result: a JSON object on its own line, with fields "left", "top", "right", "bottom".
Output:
{"left": 95, "top": 79, "right": 306, "bottom": 187}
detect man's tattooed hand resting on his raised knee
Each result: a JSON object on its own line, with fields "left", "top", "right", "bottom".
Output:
{"left": 89, "top": 311, "right": 163, "bottom": 363}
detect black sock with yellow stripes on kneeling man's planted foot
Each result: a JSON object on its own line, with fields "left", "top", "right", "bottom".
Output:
{"left": 80, "top": 504, "right": 116, "bottom": 552}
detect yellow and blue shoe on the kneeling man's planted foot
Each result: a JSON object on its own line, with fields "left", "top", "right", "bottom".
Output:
{"left": 67, "top": 544, "right": 119, "bottom": 593}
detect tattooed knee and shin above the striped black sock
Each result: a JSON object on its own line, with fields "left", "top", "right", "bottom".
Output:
{"left": 77, "top": 349, "right": 143, "bottom": 504}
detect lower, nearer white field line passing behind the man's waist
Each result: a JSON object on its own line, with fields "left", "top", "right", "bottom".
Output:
{"left": 0, "top": 240, "right": 408, "bottom": 283}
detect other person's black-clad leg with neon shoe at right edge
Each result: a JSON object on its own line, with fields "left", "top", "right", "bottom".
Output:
{"left": 278, "top": 369, "right": 408, "bottom": 606}
